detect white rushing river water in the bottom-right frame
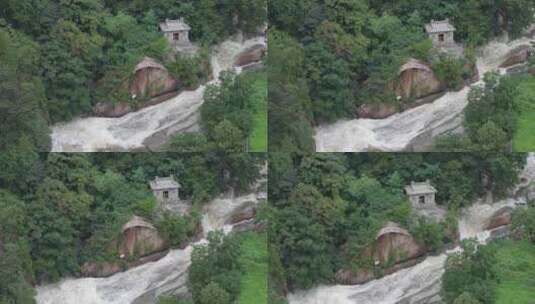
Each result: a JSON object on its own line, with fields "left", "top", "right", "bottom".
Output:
{"left": 288, "top": 153, "right": 535, "bottom": 304}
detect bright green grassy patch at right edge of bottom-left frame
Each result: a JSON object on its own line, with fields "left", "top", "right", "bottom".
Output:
{"left": 238, "top": 232, "right": 268, "bottom": 304}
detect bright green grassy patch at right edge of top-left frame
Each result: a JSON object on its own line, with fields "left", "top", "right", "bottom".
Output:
{"left": 249, "top": 71, "right": 267, "bottom": 152}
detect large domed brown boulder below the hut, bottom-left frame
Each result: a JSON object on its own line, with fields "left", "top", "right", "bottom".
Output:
{"left": 119, "top": 216, "right": 167, "bottom": 257}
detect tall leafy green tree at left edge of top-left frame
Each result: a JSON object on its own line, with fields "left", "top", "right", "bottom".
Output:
{"left": 0, "top": 27, "right": 50, "bottom": 153}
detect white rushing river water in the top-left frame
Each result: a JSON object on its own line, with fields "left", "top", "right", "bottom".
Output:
{"left": 52, "top": 35, "right": 266, "bottom": 152}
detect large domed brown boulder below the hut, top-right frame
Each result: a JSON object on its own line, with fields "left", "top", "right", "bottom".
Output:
{"left": 394, "top": 59, "right": 446, "bottom": 100}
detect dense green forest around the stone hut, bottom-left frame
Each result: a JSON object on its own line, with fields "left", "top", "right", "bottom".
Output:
{"left": 0, "top": 153, "right": 265, "bottom": 304}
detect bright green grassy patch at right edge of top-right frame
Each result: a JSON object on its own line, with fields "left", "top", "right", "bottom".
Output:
{"left": 513, "top": 76, "right": 535, "bottom": 152}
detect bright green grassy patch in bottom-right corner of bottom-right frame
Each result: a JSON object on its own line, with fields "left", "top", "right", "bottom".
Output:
{"left": 493, "top": 240, "right": 535, "bottom": 304}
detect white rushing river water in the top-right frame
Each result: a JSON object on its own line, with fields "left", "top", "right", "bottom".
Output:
{"left": 315, "top": 34, "right": 534, "bottom": 152}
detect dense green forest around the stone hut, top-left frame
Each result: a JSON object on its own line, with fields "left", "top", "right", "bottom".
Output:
{"left": 0, "top": 0, "right": 266, "bottom": 151}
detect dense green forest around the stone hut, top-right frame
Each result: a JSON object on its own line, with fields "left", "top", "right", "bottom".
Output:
{"left": 268, "top": 0, "right": 535, "bottom": 151}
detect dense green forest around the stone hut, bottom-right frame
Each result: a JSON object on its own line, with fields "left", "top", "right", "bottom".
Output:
{"left": 269, "top": 153, "right": 525, "bottom": 303}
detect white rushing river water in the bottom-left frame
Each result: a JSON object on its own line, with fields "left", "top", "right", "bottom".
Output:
{"left": 36, "top": 189, "right": 261, "bottom": 304}
